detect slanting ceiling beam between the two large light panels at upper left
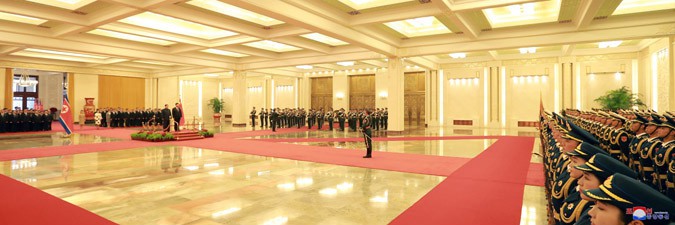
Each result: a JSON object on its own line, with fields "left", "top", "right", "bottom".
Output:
{"left": 152, "top": 5, "right": 268, "bottom": 38}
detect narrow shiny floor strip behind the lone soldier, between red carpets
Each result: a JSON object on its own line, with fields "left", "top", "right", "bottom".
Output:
{"left": 290, "top": 139, "right": 497, "bottom": 158}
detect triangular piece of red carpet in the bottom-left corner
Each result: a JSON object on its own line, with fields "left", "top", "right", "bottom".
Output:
{"left": 0, "top": 175, "right": 115, "bottom": 225}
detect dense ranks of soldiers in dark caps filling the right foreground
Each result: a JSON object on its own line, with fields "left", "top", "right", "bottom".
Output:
{"left": 540, "top": 109, "right": 675, "bottom": 224}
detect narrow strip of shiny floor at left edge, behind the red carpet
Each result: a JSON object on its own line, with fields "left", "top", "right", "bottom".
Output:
{"left": 0, "top": 132, "right": 120, "bottom": 150}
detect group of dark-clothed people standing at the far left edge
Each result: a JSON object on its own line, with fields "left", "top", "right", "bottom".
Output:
{"left": 0, "top": 108, "right": 52, "bottom": 133}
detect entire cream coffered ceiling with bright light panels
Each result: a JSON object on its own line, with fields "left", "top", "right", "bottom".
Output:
{"left": 0, "top": 0, "right": 675, "bottom": 77}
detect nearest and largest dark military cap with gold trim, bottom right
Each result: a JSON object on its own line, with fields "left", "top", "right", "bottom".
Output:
{"left": 582, "top": 173, "right": 675, "bottom": 217}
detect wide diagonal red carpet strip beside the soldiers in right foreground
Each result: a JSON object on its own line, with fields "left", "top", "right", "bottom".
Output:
{"left": 390, "top": 137, "right": 534, "bottom": 225}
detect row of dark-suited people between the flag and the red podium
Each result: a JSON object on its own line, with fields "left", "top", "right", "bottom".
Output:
{"left": 94, "top": 108, "right": 172, "bottom": 127}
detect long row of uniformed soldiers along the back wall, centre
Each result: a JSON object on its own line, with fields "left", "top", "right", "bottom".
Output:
{"left": 249, "top": 107, "right": 389, "bottom": 131}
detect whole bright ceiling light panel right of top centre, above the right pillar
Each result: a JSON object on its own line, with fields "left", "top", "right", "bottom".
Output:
{"left": 384, "top": 16, "right": 452, "bottom": 37}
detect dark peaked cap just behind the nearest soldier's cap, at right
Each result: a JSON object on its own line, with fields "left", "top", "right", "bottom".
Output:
{"left": 574, "top": 154, "right": 637, "bottom": 181}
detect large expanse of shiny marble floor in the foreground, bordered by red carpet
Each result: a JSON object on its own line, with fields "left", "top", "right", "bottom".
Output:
{"left": 0, "top": 146, "right": 445, "bottom": 224}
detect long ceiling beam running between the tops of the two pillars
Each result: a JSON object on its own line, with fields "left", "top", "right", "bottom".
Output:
{"left": 241, "top": 52, "right": 384, "bottom": 70}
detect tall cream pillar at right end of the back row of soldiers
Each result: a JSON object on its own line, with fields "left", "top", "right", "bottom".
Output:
{"left": 387, "top": 57, "right": 405, "bottom": 131}
